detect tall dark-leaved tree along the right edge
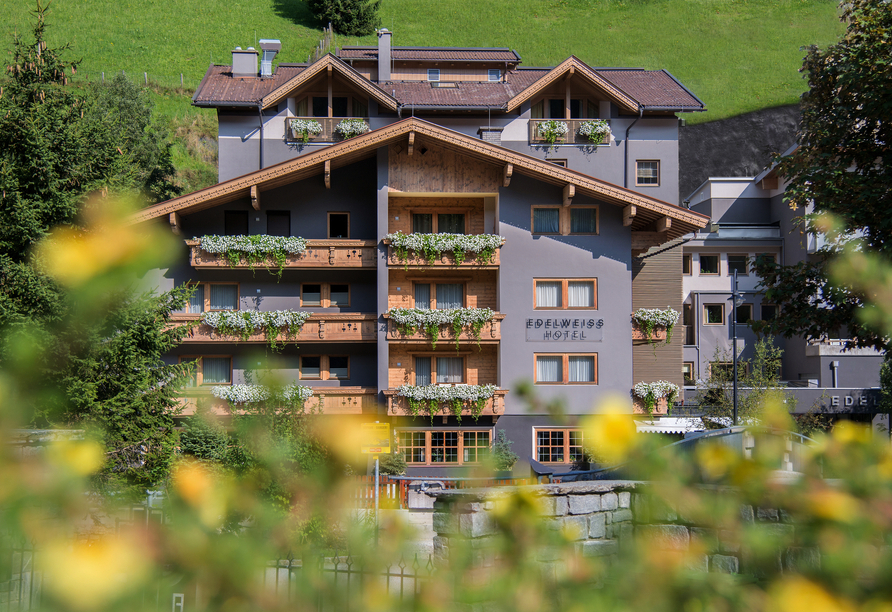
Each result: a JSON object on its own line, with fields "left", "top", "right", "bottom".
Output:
{"left": 756, "top": 0, "right": 892, "bottom": 349}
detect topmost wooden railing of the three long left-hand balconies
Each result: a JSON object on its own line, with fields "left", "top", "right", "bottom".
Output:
{"left": 186, "top": 239, "right": 377, "bottom": 270}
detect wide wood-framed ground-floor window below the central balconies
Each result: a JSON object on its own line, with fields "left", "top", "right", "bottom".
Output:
{"left": 397, "top": 430, "right": 490, "bottom": 465}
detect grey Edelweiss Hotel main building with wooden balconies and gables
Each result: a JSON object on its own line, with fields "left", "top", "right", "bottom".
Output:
{"left": 137, "top": 31, "right": 708, "bottom": 475}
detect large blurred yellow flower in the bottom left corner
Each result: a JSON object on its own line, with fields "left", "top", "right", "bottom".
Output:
{"left": 43, "top": 537, "right": 152, "bottom": 610}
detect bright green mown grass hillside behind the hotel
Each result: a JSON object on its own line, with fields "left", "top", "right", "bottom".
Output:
{"left": 0, "top": 0, "right": 844, "bottom": 189}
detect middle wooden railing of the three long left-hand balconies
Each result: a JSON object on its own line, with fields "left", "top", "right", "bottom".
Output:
{"left": 173, "top": 312, "right": 378, "bottom": 344}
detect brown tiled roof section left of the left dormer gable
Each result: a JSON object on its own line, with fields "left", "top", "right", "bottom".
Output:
{"left": 192, "top": 64, "right": 306, "bottom": 106}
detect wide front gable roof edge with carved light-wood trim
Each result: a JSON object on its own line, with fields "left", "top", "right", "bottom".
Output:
{"left": 131, "top": 117, "right": 709, "bottom": 239}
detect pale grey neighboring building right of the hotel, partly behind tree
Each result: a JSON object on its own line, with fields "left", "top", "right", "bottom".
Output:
{"left": 681, "top": 158, "right": 883, "bottom": 421}
